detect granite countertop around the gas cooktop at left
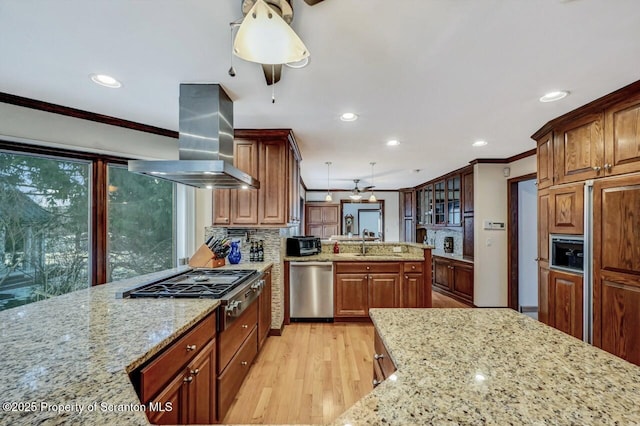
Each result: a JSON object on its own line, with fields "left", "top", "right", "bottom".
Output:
{"left": 0, "top": 262, "right": 271, "bottom": 425}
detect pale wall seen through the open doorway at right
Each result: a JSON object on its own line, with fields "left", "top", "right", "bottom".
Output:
{"left": 518, "top": 179, "right": 538, "bottom": 306}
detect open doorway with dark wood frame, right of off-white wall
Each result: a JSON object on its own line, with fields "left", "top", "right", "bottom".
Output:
{"left": 507, "top": 173, "right": 538, "bottom": 318}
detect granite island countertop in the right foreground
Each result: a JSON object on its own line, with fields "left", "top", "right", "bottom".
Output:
{"left": 334, "top": 309, "right": 640, "bottom": 426}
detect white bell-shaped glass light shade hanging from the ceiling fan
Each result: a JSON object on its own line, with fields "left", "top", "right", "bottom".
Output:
{"left": 233, "top": 0, "right": 309, "bottom": 64}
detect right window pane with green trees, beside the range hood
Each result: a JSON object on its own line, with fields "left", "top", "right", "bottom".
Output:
{"left": 107, "top": 165, "right": 175, "bottom": 282}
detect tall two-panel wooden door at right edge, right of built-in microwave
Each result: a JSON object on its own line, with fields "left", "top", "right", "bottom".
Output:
{"left": 593, "top": 175, "right": 640, "bottom": 365}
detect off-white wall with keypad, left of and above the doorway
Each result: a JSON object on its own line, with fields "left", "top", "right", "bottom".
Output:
{"left": 473, "top": 155, "right": 536, "bottom": 307}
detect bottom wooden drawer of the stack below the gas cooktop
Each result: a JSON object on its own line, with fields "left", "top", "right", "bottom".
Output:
{"left": 218, "top": 327, "right": 258, "bottom": 421}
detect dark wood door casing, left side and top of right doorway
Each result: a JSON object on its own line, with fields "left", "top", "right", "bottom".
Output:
{"left": 507, "top": 172, "right": 537, "bottom": 311}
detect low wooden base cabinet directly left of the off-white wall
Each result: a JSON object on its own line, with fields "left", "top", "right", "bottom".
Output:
{"left": 433, "top": 256, "right": 473, "bottom": 304}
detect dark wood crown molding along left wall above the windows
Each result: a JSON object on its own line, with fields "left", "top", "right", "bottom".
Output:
{"left": 0, "top": 92, "right": 178, "bottom": 139}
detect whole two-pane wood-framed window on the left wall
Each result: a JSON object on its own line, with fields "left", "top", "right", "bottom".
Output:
{"left": 0, "top": 148, "right": 176, "bottom": 310}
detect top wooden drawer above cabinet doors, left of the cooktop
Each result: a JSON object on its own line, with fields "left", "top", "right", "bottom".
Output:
{"left": 140, "top": 312, "right": 216, "bottom": 403}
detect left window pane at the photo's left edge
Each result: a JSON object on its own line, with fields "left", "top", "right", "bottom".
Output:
{"left": 0, "top": 151, "right": 90, "bottom": 310}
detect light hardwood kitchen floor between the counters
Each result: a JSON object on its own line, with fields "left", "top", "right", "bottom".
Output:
{"left": 224, "top": 292, "right": 468, "bottom": 424}
